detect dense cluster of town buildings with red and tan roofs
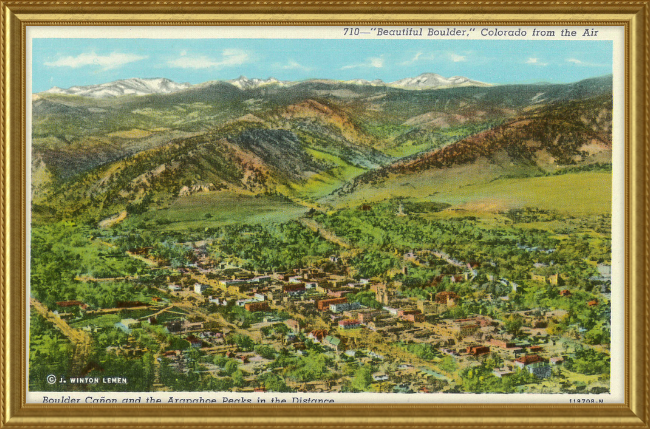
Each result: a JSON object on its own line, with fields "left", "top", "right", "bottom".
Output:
{"left": 57, "top": 239, "right": 611, "bottom": 389}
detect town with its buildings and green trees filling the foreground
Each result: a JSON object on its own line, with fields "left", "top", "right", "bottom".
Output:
{"left": 30, "top": 202, "right": 611, "bottom": 393}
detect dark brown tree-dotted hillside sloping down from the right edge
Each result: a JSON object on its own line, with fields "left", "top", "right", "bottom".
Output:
{"left": 348, "top": 96, "right": 612, "bottom": 189}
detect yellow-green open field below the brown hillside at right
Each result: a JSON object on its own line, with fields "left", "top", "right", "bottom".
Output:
{"left": 327, "top": 168, "right": 612, "bottom": 216}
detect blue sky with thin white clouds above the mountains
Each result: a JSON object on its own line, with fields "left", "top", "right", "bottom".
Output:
{"left": 32, "top": 38, "right": 613, "bottom": 93}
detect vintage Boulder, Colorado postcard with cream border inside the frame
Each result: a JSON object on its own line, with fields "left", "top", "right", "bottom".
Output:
{"left": 25, "top": 25, "right": 625, "bottom": 404}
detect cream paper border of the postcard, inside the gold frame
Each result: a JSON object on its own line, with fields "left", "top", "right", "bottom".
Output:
{"left": 24, "top": 23, "right": 626, "bottom": 405}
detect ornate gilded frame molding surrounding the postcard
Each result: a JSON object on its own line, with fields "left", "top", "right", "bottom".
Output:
{"left": 0, "top": 0, "right": 650, "bottom": 428}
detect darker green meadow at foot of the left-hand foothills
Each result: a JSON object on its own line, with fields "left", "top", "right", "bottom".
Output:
{"left": 124, "top": 192, "right": 308, "bottom": 230}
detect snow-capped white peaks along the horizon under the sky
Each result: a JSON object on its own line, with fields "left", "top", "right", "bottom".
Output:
{"left": 39, "top": 73, "right": 492, "bottom": 98}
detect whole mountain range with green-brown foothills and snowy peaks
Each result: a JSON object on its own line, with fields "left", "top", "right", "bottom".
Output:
{"left": 32, "top": 75, "right": 612, "bottom": 223}
